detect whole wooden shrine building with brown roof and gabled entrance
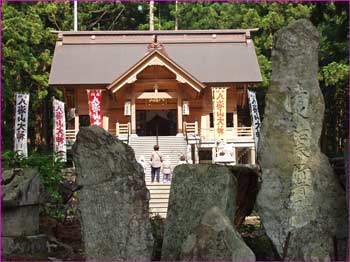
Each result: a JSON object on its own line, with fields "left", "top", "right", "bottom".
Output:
{"left": 49, "top": 29, "right": 262, "bottom": 164}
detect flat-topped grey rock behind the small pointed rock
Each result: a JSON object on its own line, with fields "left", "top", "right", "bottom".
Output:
{"left": 162, "top": 165, "right": 237, "bottom": 260}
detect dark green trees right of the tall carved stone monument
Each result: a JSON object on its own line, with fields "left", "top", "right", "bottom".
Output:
{"left": 311, "top": 3, "right": 349, "bottom": 156}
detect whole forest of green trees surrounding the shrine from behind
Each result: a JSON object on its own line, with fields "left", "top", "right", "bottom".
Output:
{"left": 2, "top": 1, "right": 349, "bottom": 156}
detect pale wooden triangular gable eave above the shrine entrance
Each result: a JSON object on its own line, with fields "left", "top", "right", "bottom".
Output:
{"left": 107, "top": 50, "right": 205, "bottom": 93}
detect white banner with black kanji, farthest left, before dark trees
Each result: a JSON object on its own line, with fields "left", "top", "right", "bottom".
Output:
{"left": 14, "top": 93, "right": 29, "bottom": 157}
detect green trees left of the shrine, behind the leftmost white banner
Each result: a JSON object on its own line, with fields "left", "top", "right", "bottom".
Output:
{"left": 2, "top": 3, "right": 68, "bottom": 151}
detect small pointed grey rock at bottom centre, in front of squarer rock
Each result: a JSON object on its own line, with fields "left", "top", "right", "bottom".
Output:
{"left": 180, "top": 207, "right": 255, "bottom": 261}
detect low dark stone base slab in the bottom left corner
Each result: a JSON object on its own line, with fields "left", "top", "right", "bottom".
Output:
{"left": 2, "top": 235, "right": 47, "bottom": 256}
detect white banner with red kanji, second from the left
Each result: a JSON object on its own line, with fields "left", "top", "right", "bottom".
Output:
{"left": 53, "top": 99, "right": 67, "bottom": 162}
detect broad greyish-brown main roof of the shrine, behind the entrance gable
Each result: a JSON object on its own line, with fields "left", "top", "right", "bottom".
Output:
{"left": 49, "top": 29, "right": 262, "bottom": 85}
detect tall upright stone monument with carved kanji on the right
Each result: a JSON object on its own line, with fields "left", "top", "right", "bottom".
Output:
{"left": 257, "top": 20, "right": 347, "bottom": 260}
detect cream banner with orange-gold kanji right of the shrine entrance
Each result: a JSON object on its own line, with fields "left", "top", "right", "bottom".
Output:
{"left": 212, "top": 87, "right": 226, "bottom": 142}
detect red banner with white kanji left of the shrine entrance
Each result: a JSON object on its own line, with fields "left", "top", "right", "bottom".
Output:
{"left": 87, "top": 90, "right": 102, "bottom": 127}
